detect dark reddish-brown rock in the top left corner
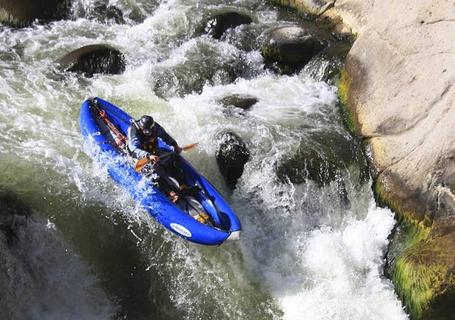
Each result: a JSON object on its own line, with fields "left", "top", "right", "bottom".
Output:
{"left": 0, "top": 0, "right": 71, "bottom": 26}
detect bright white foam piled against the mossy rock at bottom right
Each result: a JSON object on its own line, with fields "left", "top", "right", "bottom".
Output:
{"left": 271, "top": 203, "right": 406, "bottom": 320}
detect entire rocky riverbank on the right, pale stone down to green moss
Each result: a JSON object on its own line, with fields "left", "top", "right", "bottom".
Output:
{"left": 279, "top": 0, "right": 455, "bottom": 319}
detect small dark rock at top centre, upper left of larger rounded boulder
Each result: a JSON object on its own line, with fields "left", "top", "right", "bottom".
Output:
{"left": 205, "top": 11, "right": 253, "bottom": 39}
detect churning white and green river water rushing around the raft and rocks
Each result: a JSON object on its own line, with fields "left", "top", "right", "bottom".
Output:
{"left": 0, "top": 0, "right": 407, "bottom": 320}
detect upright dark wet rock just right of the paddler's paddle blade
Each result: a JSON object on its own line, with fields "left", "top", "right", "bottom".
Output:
{"left": 215, "top": 131, "right": 250, "bottom": 188}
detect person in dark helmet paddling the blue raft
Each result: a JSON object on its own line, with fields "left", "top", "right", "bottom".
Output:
{"left": 127, "top": 115, "right": 182, "bottom": 202}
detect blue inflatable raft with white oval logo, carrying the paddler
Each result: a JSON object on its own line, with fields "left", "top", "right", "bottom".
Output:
{"left": 80, "top": 98, "right": 241, "bottom": 245}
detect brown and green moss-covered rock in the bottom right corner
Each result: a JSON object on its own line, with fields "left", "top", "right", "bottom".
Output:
{"left": 380, "top": 172, "right": 455, "bottom": 320}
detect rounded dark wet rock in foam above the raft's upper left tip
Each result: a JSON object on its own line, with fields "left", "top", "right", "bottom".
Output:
{"left": 57, "top": 44, "right": 125, "bottom": 77}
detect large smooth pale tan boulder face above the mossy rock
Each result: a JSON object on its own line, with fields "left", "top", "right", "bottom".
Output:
{"left": 346, "top": 1, "right": 455, "bottom": 224}
